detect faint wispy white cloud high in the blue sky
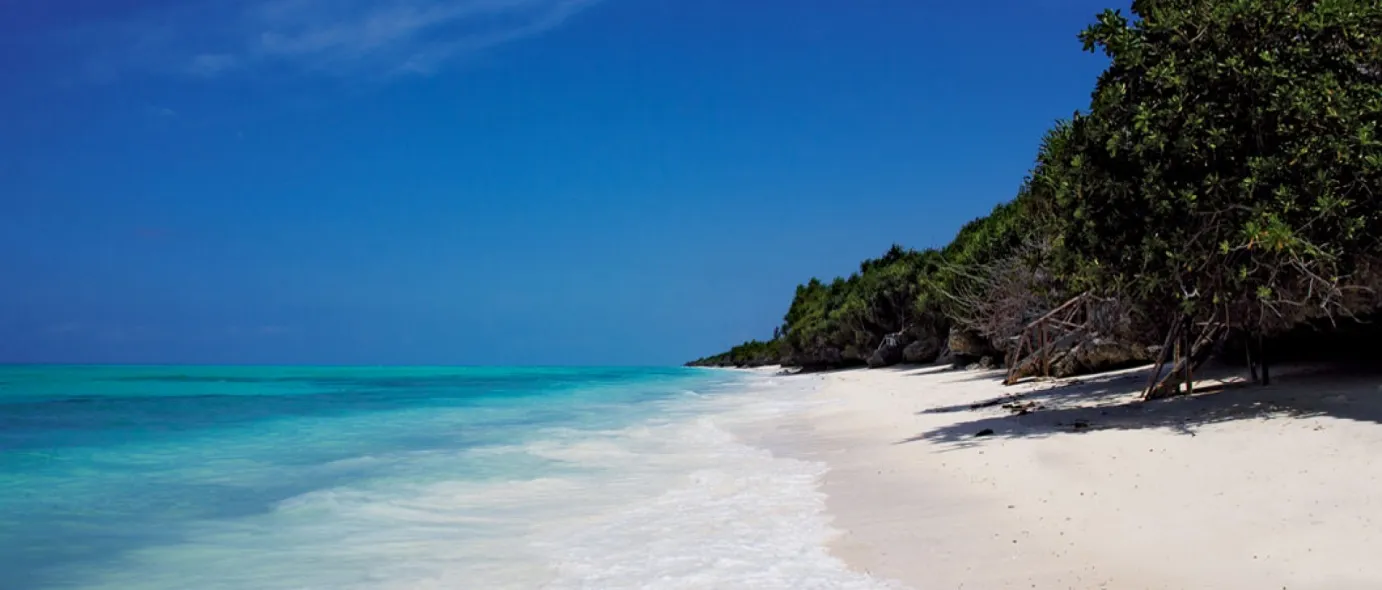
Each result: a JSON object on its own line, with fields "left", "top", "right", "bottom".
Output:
{"left": 52, "top": 0, "right": 600, "bottom": 77}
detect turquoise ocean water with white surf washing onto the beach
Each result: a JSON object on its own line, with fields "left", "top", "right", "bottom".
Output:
{"left": 0, "top": 366, "right": 883, "bottom": 590}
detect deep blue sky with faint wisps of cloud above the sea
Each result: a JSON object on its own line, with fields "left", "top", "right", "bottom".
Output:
{"left": 0, "top": 0, "right": 1125, "bottom": 365}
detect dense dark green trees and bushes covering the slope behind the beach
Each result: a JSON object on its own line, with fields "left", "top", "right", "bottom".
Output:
{"left": 691, "top": 0, "right": 1382, "bottom": 378}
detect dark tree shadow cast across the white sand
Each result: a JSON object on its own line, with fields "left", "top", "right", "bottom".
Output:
{"left": 898, "top": 366, "right": 1382, "bottom": 449}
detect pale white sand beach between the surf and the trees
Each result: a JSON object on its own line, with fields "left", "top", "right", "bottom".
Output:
{"left": 763, "top": 368, "right": 1382, "bottom": 590}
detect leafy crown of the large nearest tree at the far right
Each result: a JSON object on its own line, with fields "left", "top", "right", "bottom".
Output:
{"left": 1043, "top": 0, "right": 1382, "bottom": 332}
